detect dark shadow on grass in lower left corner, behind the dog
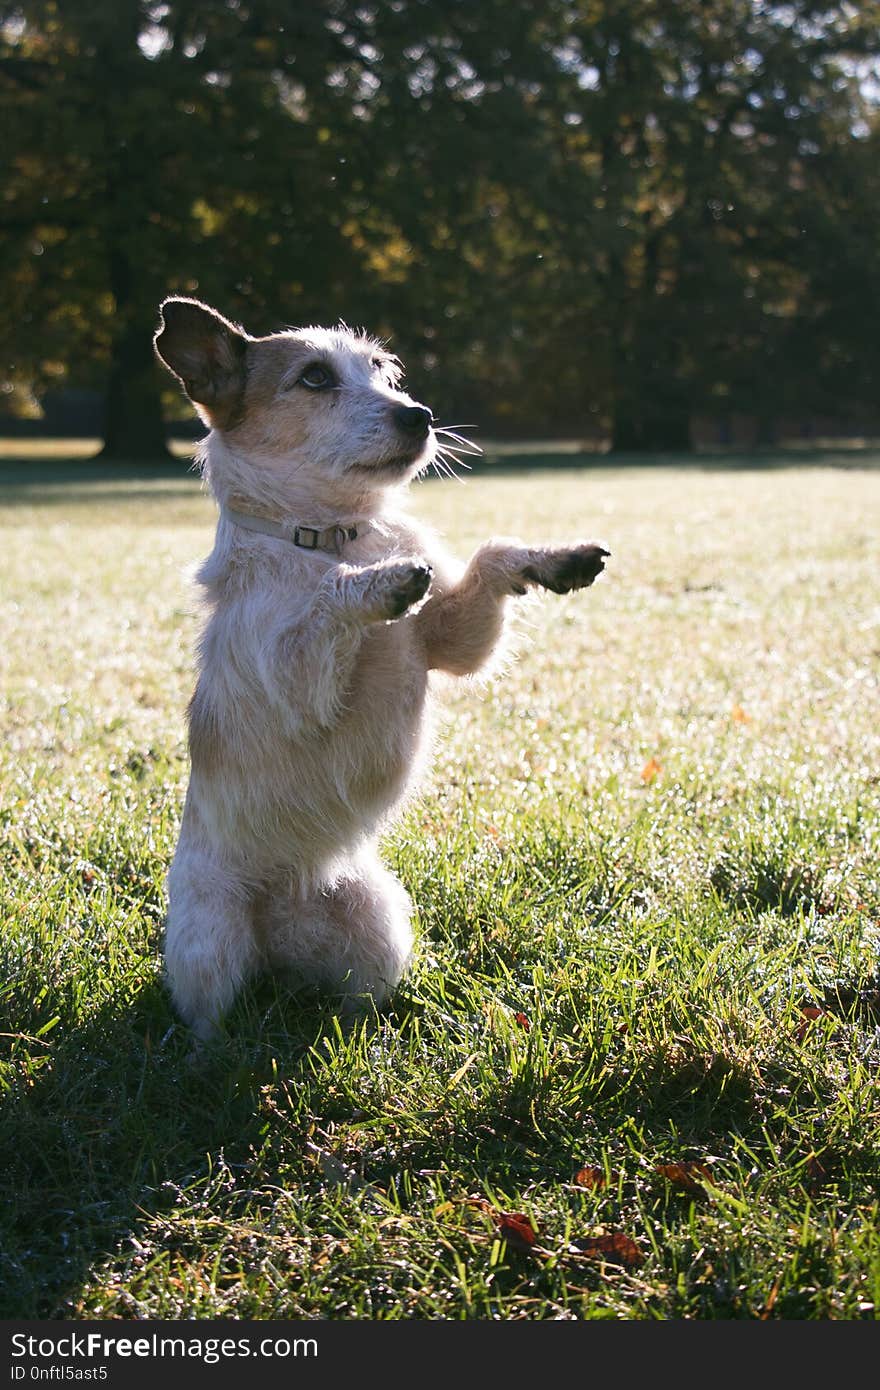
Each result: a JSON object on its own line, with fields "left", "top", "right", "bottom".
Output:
{"left": 0, "top": 980, "right": 335, "bottom": 1318}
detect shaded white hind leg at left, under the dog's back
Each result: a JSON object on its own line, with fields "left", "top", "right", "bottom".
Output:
{"left": 165, "top": 844, "right": 261, "bottom": 1041}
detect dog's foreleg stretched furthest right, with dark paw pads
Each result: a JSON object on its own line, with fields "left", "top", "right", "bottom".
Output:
{"left": 416, "top": 541, "right": 609, "bottom": 676}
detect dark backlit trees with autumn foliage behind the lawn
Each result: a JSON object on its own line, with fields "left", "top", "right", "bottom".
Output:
{"left": 0, "top": 0, "right": 880, "bottom": 455}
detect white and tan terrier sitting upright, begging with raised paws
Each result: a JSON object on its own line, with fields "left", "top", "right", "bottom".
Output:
{"left": 154, "top": 297, "right": 609, "bottom": 1040}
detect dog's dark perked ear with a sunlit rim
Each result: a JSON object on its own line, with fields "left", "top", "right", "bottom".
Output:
{"left": 153, "top": 299, "right": 250, "bottom": 428}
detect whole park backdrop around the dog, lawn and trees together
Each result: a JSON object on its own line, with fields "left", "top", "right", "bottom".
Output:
{"left": 0, "top": 0, "right": 880, "bottom": 1325}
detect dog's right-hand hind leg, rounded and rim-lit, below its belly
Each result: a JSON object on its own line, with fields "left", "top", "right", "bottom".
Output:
{"left": 264, "top": 849, "right": 413, "bottom": 1009}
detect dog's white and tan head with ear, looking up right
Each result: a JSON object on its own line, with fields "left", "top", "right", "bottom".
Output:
{"left": 156, "top": 297, "right": 434, "bottom": 505}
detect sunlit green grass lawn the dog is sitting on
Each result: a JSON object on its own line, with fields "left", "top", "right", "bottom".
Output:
{"left": 0, "top": 460, "right": 880, "bottom": 1319}
